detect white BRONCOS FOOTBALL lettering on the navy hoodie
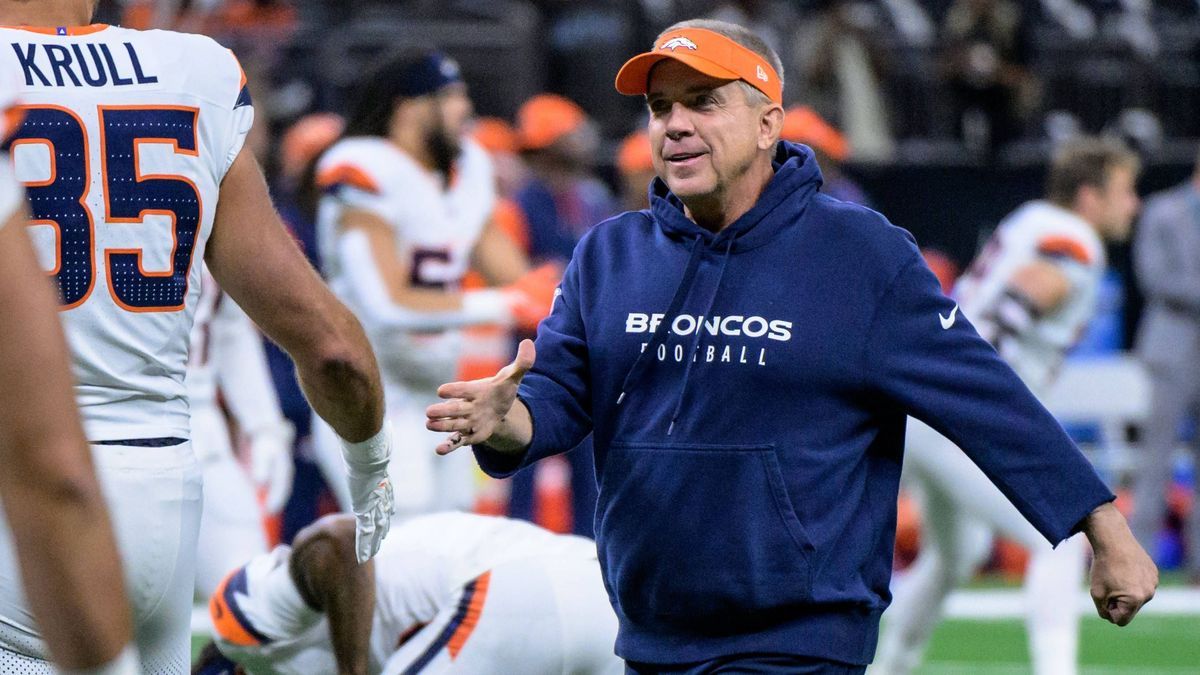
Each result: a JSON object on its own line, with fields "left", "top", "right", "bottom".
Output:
{"left": 625, "top": 312, "right": 792, "bottom": 365}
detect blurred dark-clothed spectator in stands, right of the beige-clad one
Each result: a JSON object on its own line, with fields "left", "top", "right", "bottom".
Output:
{"left": 942, "top": 0, "right": 1036, "bottom": 151}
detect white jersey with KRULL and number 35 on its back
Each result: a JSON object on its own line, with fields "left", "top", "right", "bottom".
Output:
{"left": 0, "top": 24, "right": 253, "bottom": 441}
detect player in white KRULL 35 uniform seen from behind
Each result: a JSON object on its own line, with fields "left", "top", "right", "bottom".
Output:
{"left": 0, "top": 0, "right": 391, "bottom": 674}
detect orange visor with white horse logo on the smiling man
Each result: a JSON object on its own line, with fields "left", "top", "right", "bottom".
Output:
{"left": 617, "top": 28, "right": 784, "bottom": 103}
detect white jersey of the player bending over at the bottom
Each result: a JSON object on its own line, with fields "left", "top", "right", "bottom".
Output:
{"left": 210, "top": 513, "right": 596, "bottom": 675}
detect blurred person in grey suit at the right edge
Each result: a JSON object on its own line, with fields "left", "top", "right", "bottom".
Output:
{"left": 1129, "top": 151, "right": 1200, "bottom": 583}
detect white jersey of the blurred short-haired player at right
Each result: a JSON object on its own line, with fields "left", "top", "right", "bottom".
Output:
{"left": 954, "top": 201, "right": 1105, "bottom": 394}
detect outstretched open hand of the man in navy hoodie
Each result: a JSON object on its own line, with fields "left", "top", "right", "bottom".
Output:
{"left": 425, "top": 340, "right": 536, "bottom": 455}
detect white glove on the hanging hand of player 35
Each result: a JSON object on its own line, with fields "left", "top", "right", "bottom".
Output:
{"left": 342, "top": 422, "right": 395, "bottom": 563}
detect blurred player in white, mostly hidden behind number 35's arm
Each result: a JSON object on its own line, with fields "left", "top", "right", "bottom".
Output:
{"left": 187, "top": 268, "right": 295, "bottom": 598}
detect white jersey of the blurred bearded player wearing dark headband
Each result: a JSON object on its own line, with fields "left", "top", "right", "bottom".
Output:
{"left": 317, "top": 137, "right": 496, "bottom": 388}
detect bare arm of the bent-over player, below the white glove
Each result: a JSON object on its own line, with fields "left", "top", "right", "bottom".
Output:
{"left": 288, "top": 516, "right": 376, "bottom": 675}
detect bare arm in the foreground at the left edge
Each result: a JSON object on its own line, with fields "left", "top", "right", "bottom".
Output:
{"left": 0, "top": 215, "right": 132, "bottom": 669}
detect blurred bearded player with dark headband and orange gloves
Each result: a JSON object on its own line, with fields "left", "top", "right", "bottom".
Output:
{"left": 314, "top": 53, "right": 558, "bottom": 515}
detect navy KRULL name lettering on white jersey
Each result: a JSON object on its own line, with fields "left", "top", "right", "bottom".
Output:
{"left": 12, "top": 42, "right": 158, "bottom": 86}
